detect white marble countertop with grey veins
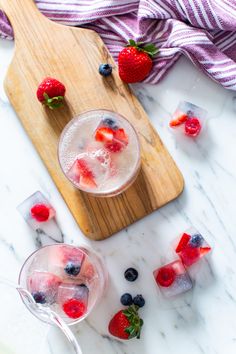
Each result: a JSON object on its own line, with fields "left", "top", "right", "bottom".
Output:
{"left": 0, "top": 41, "right": 236, "bottom": 354}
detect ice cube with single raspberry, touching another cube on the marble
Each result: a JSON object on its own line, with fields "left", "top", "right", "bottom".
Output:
{"left": 153, "top": 260, "right": 193, "bottom": 298}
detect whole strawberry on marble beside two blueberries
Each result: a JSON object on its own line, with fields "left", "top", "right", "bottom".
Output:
{"left": 108, "top": 305, "right": 143, "bottom": 339}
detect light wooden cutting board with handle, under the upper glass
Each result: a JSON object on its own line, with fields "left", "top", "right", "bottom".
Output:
{"left": 0, "top": 0, "right": 183, "bottom": 240}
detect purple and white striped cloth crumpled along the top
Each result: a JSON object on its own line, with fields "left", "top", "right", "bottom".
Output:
{"left": 0, "top": 0, "right": 236, "bottom": 90}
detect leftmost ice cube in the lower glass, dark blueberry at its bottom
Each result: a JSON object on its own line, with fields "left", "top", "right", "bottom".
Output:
{"left": 27, "top": 271, "right": 62, "bottom": 304}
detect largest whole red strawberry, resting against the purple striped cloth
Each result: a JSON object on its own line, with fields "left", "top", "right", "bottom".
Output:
{"left": 118, "top": 39, "right": 158, "bottom": 83}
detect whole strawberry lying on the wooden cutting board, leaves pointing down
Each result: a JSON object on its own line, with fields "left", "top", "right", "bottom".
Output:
{"left": 37, "top": 77, "right": 66, "bottom": 109}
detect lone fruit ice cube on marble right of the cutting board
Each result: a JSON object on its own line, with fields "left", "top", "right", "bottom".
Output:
{"left": 169, "top": 101, "right": 207, "bottom": 137}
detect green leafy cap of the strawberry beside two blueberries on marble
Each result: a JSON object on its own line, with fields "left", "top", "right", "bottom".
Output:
{"left": 123, "top": 305, "right": 143, "bottom": 339}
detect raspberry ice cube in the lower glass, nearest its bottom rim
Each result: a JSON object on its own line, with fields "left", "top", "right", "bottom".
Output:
{"left": 57, "top": 283, "right": 89, "bottom": 319}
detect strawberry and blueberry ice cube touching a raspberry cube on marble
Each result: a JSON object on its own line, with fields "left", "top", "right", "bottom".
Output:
{"left": 175, "top": 228, "right": 211, "bottom": 267}
